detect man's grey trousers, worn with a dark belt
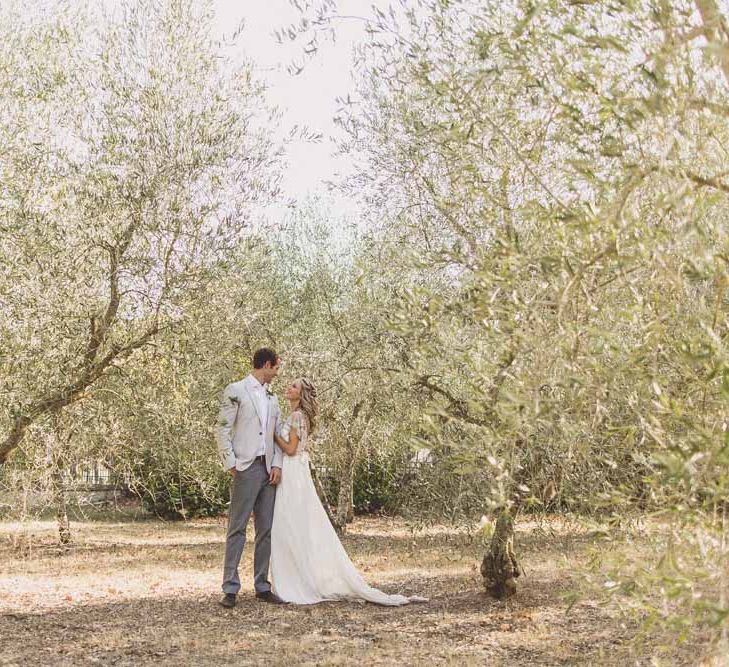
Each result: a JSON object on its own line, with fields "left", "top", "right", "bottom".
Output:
{"left": 223, "top": 461, "right": 276, "bottom": 593}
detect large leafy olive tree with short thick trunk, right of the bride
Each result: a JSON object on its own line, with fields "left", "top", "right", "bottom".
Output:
{"left": 332, "top": 1, "right": 728, "bottom": 618}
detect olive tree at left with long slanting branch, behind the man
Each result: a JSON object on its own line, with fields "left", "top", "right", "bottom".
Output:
{"left": 0, "top": 0, "right": 277, "bottom": 462}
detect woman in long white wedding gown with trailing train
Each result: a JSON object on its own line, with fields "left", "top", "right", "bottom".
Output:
{"left": 271, "top": 378, "right": 427, "bottom": 606}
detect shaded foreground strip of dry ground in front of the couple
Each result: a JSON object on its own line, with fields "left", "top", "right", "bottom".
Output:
{"left": 0, "top": 575, "right": 672, "bottom": 666}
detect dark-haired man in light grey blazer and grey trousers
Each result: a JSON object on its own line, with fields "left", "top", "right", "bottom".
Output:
{"left": 217, "top": 347, "right": 283, "bottom": 607}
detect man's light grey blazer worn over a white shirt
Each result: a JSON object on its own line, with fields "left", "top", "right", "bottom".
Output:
{"left": 216, "top": 376, "right": 283, "bottom": 472}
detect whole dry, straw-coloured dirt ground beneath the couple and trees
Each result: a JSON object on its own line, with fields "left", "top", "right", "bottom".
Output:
{"left": 0, "top": 518, "right": 708, "bottom": 666}
